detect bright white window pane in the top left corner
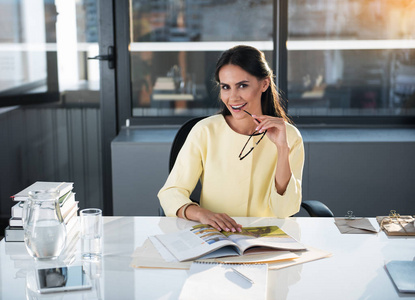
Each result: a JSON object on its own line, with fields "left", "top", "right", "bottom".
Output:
{"left": 0, "top": 1, "right": 52, "bottom": 102}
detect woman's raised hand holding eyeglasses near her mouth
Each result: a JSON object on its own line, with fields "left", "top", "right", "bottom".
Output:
{"left": 252, "top": 115, "right": 288, "bottom": 149}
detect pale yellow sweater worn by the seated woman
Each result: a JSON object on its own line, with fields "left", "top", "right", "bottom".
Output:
{"left": 158, "top": 115, "right": 304, "bottom": 218}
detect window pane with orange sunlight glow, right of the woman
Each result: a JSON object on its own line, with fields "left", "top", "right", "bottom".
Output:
{"left": 287, "top": 0, "right": 415, "bottom": 117}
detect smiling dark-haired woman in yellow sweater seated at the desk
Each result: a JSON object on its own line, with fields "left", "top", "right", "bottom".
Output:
{"left": 158, "top": 46, "right": 304, "bottom": 232}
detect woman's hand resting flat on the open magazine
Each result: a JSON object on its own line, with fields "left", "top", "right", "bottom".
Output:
{"left": 178, "top": 205, "right": 242, "bottom": 232}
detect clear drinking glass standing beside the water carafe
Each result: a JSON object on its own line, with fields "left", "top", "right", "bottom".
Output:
{"left": 80, "top": 208, "right": 102, "bottom": 260}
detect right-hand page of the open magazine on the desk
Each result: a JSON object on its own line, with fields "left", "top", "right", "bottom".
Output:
{"left": 222, "top": 226, "right": 306, "bottom": 254}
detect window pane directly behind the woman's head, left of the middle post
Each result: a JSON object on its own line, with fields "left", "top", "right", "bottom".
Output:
{"left": 129, "top": 0, "right": 274, "bottom": 117}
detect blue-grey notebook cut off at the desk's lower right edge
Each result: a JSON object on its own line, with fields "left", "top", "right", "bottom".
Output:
{"left": 385, "top": 260, "right": 415, "bottom": 293}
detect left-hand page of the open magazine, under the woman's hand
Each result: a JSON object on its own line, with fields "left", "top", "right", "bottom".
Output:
{"left": 156, "top": 224, "right": 238, "bottom": 261}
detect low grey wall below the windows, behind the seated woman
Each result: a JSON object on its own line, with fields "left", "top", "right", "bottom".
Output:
{"left": 112, "top": 127, "right": 415, "bottom": 217}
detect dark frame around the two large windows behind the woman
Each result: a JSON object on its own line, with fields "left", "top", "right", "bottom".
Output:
{"left": 114, "top": 0, "right": 415, "bottom": 127}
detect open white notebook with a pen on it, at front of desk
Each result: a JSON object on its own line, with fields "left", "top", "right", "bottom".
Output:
{"left": 179, "top": 261, "right": 268, "bottom": 300}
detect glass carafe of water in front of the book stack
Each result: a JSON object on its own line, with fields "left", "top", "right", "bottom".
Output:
{"left": 23, "top": 189, "right": 66, "bottom": 260}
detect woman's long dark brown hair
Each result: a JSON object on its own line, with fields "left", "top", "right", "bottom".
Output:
{"left": 215, "top": 45, "right": 291, "bottom": 123}
